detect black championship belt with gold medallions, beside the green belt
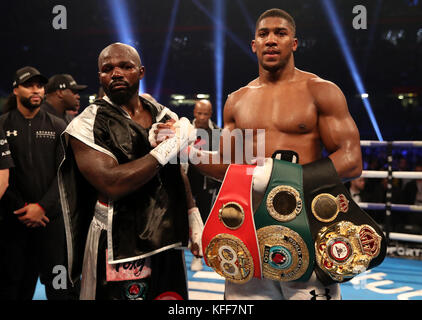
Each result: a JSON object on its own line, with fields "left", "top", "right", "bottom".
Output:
{"left": 303, "top": 158, "right": 386, "bottom": 285}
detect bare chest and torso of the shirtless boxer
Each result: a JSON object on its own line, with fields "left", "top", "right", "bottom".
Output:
{"left": 227, "top": 69, "right": 322, "bottom": 164}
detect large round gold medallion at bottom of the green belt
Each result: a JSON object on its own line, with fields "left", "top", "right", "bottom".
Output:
{"left": 257, "top": 225, "right": 309, "bottom": 281}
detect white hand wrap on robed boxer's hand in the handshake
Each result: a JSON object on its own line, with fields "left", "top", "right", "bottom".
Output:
{"left": 149, "top": 118, "right": 196, "bottom": 166}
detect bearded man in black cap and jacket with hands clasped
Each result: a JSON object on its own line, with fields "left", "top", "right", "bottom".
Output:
{"left": 0, "top": 67, "right": 76, "bottom": 300}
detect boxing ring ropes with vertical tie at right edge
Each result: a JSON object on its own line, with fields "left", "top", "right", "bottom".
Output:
{"left": 358, "top": 140, "right": 422, "bottom": 243}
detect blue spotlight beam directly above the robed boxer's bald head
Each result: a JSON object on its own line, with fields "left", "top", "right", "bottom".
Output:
{"left": 107, "top": 0, "right": 145, "bottom": 93}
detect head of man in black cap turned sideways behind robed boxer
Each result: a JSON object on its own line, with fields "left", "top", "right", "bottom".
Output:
{"left": 41, "top": 74, "right": 87, "bottom": 124}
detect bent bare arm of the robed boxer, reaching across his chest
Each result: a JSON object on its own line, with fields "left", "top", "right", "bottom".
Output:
{"left": 70, "top": 137, "right": 160, "bottom": 200}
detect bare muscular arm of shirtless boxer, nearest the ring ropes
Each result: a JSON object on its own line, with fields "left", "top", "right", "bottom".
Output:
{"left": 309, "top": 79, "right": 362, "bottom": 179}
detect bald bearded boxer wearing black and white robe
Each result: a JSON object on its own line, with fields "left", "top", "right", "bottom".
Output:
{"left": 60, "top": 43, "right": 201, "bottom": 300}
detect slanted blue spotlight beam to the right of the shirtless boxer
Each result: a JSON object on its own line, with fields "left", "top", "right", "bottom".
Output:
{"left": 322, "top": 0, "right": 384, "bottom": 141}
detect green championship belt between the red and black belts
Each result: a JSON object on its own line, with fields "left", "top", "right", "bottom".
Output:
{"left": 254, "top": 159, "right": 315, "bottom": 281}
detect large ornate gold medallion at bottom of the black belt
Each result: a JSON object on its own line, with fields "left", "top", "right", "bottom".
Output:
{"left": 315, "top": 221, "right": 381, "bottom": 282}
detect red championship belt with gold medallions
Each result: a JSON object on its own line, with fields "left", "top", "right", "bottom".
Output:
{"left": 202, "top": 164, "right": 261, "bottom": 283}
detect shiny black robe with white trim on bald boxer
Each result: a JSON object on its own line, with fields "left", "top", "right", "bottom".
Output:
{"left": 59, "top": 97, "right": 189, "bottom": 298}
